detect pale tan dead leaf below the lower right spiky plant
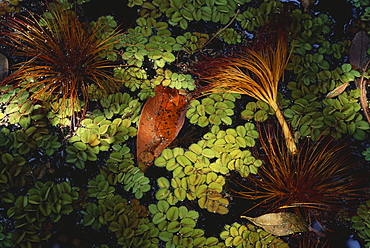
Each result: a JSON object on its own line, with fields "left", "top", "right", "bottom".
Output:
{"left": 241, "top": 212, "right": 308, "bottom": 236}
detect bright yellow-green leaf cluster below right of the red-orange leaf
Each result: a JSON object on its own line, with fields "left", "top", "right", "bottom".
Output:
{"left": 154, "top": 123, "right": 262, "bottom": 214}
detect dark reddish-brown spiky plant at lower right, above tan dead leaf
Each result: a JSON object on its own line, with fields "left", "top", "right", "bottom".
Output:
{"left": 231, "top": 122, "right": 361, "bottom": 219}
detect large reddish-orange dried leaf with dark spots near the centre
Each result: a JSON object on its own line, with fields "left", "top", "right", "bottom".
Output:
{"left": 136, "top": 85, "right": 188, "bottom": 170}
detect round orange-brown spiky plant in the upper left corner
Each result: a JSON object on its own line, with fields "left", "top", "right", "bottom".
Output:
{"left": 1, "top": 4, "right": 125, "bottom": 123}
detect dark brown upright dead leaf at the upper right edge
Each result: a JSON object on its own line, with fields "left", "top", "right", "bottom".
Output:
{"left": 349, "top": 31, "right": 369, "bottom": 69}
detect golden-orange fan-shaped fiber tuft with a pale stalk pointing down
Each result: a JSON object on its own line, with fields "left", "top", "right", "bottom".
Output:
{"left": 195, "top": 23, "right": 297, "bottom": 154}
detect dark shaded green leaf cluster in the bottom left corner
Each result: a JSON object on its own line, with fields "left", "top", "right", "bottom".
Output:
{"left": 7, "top": 181, "right": 78, "bottom": 247}
